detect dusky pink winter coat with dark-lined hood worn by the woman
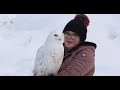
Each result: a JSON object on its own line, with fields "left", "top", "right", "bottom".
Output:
{"left": 56, "top": 42, "right": 97, "bottom": 76}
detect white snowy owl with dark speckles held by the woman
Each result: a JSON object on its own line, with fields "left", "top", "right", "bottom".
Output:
{"left": 33, "top": 31, "right": 64, "bottom": 76}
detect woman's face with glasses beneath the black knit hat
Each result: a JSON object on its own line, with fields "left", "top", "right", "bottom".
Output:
{"left": 64, "top": 31, "right": 80, "bottom": 49}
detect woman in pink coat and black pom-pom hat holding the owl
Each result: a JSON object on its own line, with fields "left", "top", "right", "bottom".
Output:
{"left": 55, "top": 14, "right": 97, "bottom": 76}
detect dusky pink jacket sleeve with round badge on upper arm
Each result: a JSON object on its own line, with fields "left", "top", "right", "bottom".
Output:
{"left": 56, "top": 49, "right": 95, "bottom": 76}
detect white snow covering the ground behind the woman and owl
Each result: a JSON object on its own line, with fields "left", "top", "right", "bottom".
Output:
{"left": 0, "top": 14, "right": 120, "bottom": 76}
